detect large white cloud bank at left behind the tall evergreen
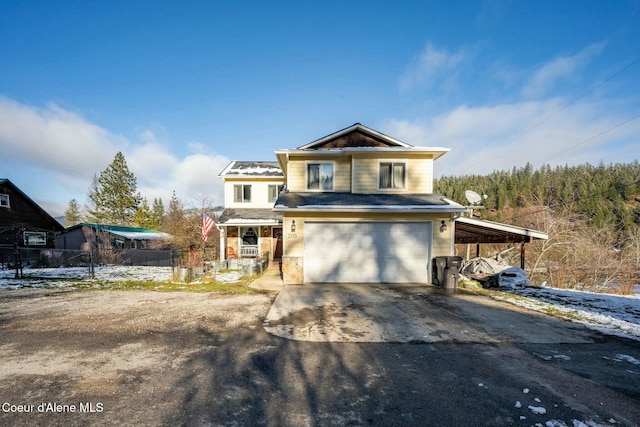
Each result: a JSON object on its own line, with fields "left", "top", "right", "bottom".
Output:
{"left": 0, "top": 97, "right": 230, "bottom": 216}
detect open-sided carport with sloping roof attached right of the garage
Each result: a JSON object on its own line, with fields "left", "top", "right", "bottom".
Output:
{"left": 454, "top": 217, "right": 549, "bottom": 269}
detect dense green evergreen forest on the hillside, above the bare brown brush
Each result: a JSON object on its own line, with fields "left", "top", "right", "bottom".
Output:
{"left": 434, "top": 160, "right": 640, "bottom": 230}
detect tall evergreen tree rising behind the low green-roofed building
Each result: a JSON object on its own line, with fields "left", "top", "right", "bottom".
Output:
{"left": 89, "top": 152, "right": 141, "bottom": 225}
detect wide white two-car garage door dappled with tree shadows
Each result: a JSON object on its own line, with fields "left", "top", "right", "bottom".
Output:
{"left": 304, "top": 222, "right": 431, "bottom": 283}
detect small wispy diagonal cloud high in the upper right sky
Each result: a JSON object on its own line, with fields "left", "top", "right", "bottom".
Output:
{"left": 521, "top": 43, "right": 605, "bottom": 98}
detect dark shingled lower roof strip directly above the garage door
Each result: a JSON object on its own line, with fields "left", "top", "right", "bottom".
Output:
{"left": 273, "top": 192, "right": 466, "bottom": 213}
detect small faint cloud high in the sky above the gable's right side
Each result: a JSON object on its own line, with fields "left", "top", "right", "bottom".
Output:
{"left": 400, "top": 42, "right": 466, "bottom": 92}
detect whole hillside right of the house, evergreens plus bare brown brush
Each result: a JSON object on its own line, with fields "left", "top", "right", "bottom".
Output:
{"left": 434, "top": 160, "right": 640, "bottom": 293}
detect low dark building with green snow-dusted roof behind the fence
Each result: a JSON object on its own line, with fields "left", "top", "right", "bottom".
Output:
{"left": 56, "top": 223, "right": 171, "bottom": 251}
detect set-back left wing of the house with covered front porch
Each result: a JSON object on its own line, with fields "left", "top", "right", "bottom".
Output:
{"left": 218, "top": 161, "right": 284, "bottom": 261}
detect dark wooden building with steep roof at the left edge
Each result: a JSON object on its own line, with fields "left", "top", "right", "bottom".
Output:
{"left": 0, "top": 179, "right": 64, "bottom": 249}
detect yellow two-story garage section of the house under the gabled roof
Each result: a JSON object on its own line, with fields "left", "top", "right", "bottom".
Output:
{"left": 274, "top": 123, "right": 465, "bottom": 284}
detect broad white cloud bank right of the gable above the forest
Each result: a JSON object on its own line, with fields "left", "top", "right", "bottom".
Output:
{"left": 382, "top": 99, "right": 640, "bottom": 176}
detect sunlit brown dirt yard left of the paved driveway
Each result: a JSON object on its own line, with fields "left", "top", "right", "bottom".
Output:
{"left": 0, "top": 289, "right": 274, "bottom": 425}
